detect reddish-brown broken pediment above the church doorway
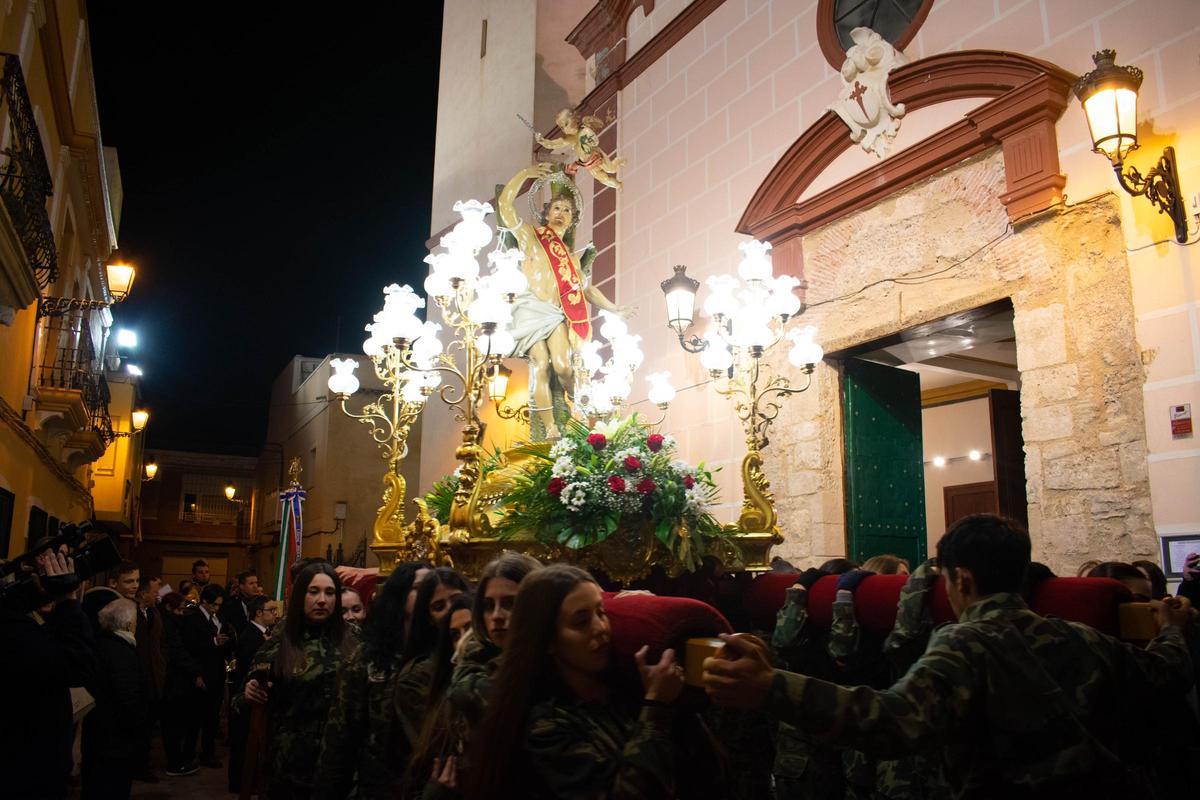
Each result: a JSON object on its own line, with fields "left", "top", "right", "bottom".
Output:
{"left": 737, "top": 50, "right": 1075, "bottom": 245}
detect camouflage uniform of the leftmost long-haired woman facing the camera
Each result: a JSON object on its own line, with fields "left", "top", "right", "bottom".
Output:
{"left": 254, "top": 631, "right": 342, "bottom": 792}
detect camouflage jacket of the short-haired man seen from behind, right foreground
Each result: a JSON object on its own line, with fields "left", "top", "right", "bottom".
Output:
{"left": 767, "top": 594, "right": 1192, "bottom": 799}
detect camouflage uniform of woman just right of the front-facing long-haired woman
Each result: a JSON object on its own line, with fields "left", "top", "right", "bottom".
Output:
{"left": 314, "top": 646, "right": 412, "bottom": 800}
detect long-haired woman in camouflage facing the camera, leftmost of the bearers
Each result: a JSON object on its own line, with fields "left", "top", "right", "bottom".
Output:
{"left": 244, "top": 563, "right": 353, "bottom": 800}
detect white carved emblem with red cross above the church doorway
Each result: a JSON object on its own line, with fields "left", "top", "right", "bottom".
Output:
{"left": 829, "top": 28, "right": 908, "bottom": 158}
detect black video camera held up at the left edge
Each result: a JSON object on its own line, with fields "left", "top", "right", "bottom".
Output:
{"left": 0, "top": 522, "right": 121, "bottom": 614}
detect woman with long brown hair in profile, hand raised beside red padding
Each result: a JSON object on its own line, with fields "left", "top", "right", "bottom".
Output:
{"left": 462, "top": 564, "right": 683, "bottom": 800}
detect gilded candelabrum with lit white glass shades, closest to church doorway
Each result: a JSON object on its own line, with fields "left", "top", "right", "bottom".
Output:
{"left": 652, "top": 241, "right": 824, "bottom": 541}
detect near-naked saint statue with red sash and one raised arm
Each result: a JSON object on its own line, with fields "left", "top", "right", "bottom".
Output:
{"left": 497, "top": 163, "right": 635, "bottom": 439}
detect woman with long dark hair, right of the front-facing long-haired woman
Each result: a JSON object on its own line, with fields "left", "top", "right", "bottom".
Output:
{"left": 317, "top": 561, "right": 430, "bottom": 800}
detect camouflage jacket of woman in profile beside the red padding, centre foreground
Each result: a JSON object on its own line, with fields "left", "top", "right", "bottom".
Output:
{"left": 523, "top": 698, "right": 676, "bottom": 800}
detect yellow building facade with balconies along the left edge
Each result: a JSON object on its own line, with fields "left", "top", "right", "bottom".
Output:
{"left": 0, "top": 0, "right": 140, "bottom": 557}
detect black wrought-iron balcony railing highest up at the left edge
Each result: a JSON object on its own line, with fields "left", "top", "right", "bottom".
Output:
{"left": 0, "top": 53, "right": 59, "bottom": 289}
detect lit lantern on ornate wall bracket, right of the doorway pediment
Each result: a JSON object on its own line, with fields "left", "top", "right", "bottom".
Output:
{"left": 1074, "top": 50, "right": 1188, "bottom": 243}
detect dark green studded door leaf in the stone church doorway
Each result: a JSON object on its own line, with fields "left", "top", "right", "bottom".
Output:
{"left": 842, "top": 359, "right": 926, "bottom": 567}
